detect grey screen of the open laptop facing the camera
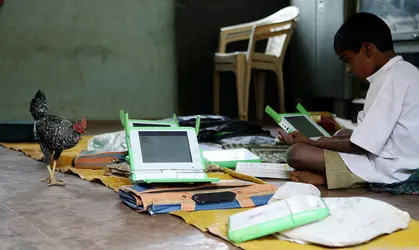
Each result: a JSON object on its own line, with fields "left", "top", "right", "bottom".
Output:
{"left": 138, "top": 131, "right": 192, "bottom": 163}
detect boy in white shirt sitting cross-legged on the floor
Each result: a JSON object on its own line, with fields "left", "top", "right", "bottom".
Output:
{"left": 279, "top": 13, "right": 419, "bottom": 189}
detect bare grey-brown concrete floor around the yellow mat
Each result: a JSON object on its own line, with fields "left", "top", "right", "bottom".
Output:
{"left": 0, "top": 123, "right": 419, "bottom": 250}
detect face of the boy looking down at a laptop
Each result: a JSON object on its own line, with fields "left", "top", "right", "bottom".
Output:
{"left": 338, "top": 43, "right": 376, "bottom": 80}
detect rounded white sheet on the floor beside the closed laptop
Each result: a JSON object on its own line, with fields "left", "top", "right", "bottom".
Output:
{"left": 275, "top": 197, "right": 410, "bottom": 247}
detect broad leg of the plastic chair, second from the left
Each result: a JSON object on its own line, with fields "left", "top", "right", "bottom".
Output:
{"left": 235, "top": 56, "right": 249, "bottom": 121}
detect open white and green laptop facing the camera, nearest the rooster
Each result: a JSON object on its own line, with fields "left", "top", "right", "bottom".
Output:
{"left": 120, "top": 111, "right": 219, "bottom": 184}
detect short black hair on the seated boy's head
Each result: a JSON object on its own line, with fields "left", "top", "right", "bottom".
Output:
{"left": 333, "top": 12, "right": 394, "bottom": 53}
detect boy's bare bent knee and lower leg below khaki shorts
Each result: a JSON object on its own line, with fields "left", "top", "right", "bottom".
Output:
{"left": 286, "top": 143, "right": 326, "bottom": 185}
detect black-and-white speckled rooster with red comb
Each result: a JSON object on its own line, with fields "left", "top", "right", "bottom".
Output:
{"left": 29, "top": 90, "right": 87, "bottom": 186}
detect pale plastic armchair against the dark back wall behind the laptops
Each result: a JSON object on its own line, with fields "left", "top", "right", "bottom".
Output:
{"left": 213, "top": 6, "right": 299, "bottom": 120}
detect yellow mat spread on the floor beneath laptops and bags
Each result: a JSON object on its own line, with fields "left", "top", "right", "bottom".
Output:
{"left": 0, "top": 136, "right": 419, "bottom": 250}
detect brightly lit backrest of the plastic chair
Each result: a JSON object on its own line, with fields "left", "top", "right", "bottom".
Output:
{"left": 255, "top": 6, "right": 300, "bottom": 57}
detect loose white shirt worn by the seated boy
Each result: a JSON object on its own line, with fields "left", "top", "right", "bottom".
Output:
{"left": 339, "top": 56, "right": 419, "bottom": 184}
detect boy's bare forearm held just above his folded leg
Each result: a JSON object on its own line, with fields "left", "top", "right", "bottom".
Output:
{"left": 307, "top": 137, "right": 368, "bottom": 154}
